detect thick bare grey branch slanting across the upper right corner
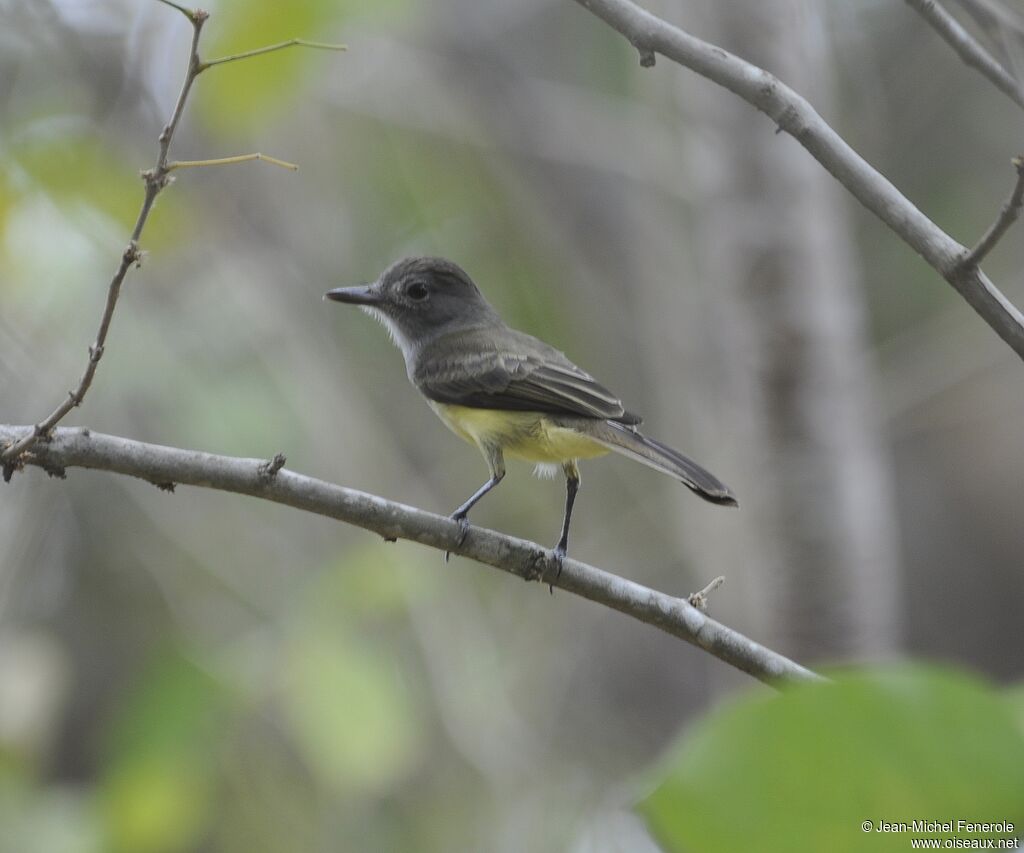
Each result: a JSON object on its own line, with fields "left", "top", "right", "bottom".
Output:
{"left": 575, "top": 0, "right": 1024, "bottom": 358}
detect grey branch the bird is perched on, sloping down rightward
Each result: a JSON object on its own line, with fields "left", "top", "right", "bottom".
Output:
{"left": 0, "top": 426, "right": 820, "bottom": 685}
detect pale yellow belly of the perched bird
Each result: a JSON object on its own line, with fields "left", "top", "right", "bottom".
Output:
{"left": 430, "top": 400, "right": 608, "bottom": 463}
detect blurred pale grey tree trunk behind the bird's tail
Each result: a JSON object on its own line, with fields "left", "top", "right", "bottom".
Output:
{"left": 671, "top": 0, "right": 899, "bottom": 662}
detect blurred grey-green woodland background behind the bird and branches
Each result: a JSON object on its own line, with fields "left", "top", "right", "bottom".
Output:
{"left": 0, "top": 0, "right": 1024, "bottom": 853}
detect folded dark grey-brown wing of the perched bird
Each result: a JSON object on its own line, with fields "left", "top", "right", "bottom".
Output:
{"left": 413, "top": 335, "right": 640, "bottom": 425}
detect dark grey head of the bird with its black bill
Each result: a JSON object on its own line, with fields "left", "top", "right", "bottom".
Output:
{"left": 327, "top": 252, "right": 501, "bottom": 360}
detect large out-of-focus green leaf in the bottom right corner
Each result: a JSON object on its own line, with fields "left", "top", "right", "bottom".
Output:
{"left": 640, "top": 666, "right": 1024, "bottom": 853}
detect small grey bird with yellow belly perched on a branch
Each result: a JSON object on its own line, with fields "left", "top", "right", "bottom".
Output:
{"left": 325, "top": 257, "right": 737, "bottom": 558}
